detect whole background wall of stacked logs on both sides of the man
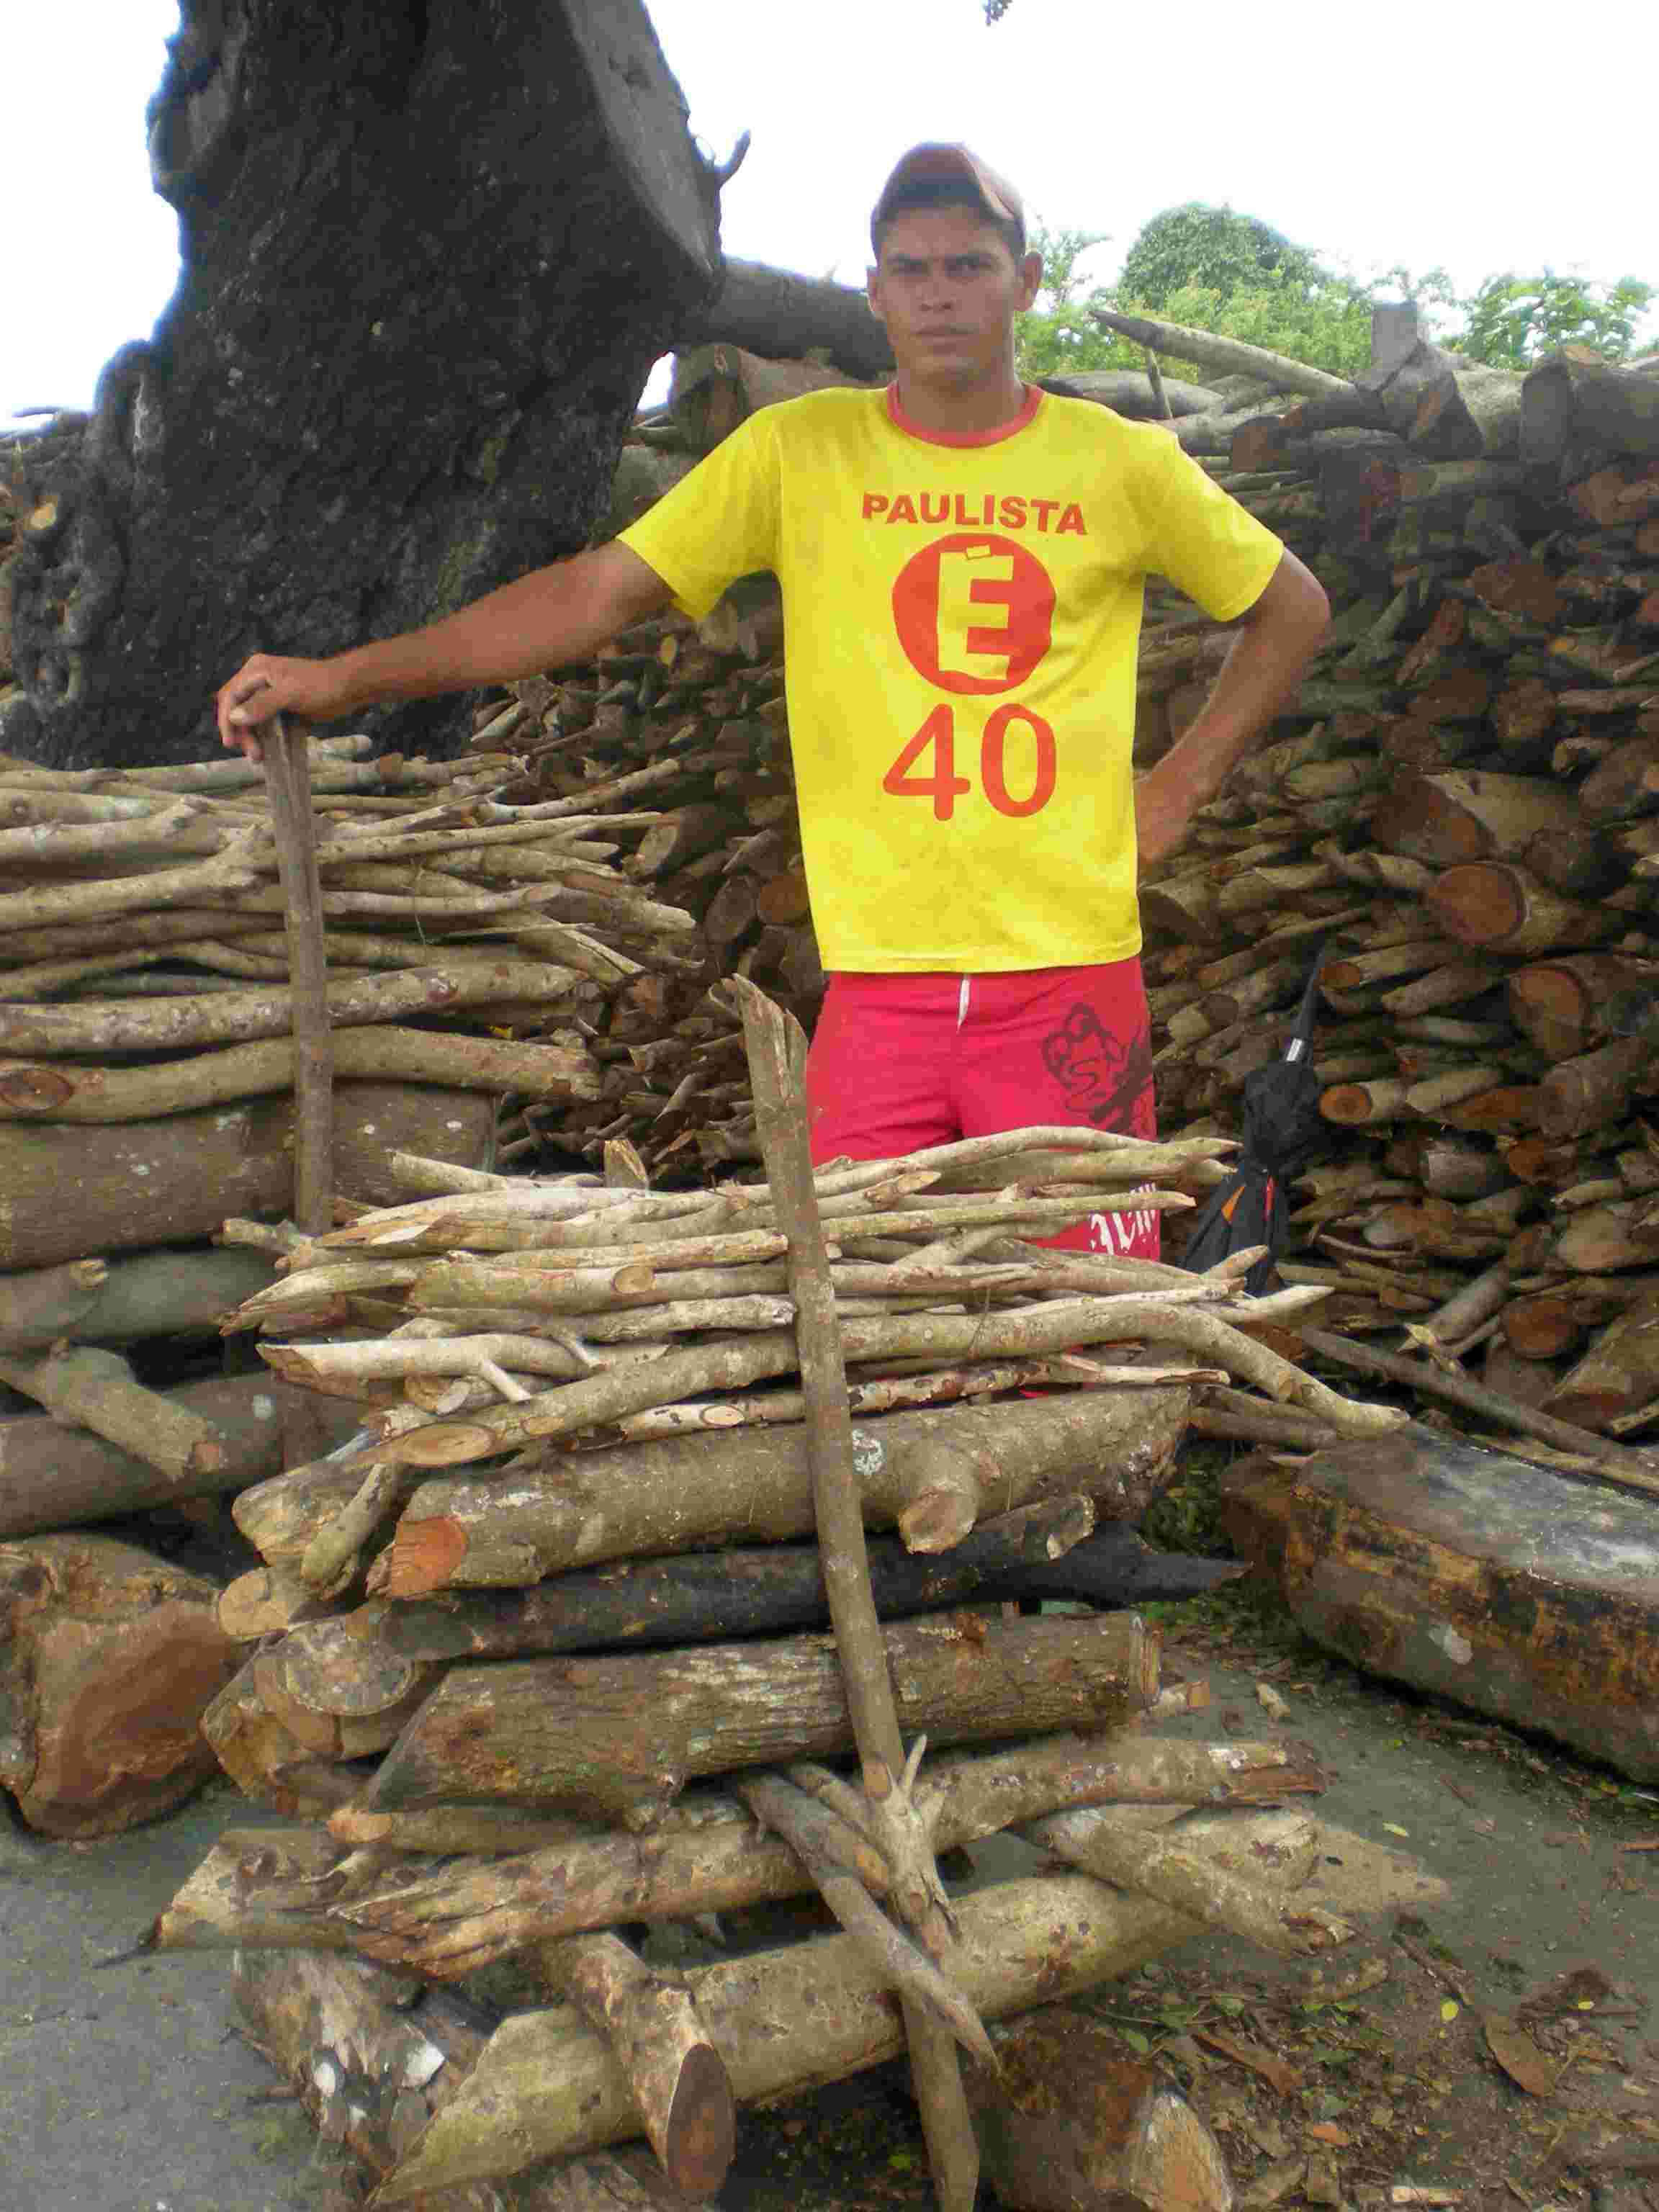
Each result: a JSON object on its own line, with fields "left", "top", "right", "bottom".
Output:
{"left": 486, "top": 310, "right": 1659, "bottom": 1426}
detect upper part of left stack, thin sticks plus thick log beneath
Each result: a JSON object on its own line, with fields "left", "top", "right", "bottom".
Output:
{"left": 0, "top": 737, "right": 708, "bottom": 1267}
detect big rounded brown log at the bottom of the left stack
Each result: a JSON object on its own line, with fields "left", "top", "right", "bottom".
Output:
{"left": 0, "top": 1535, "right": 237, "bottom": 1836}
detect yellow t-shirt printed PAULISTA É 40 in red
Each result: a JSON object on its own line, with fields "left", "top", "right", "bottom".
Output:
{"left": 621, "top": 387, "right": 1283, "bottom": 974}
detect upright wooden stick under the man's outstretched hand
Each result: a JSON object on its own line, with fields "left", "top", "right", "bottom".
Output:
{"left": 264, "top": 714, "right": 334, "bottom": 1236}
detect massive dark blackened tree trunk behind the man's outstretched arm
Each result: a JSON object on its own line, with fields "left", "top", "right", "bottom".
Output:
{"left": 0, "top": 0, "right": 721, "bottom": 768}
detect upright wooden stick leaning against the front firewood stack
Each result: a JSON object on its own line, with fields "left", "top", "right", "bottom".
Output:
{"left": 730, "top": 978, "right": 984, "bottom": 2212}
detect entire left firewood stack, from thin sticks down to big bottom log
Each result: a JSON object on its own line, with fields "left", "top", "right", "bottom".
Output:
{"left": 0, "top": 739, "right": 690, "bottom": 1836}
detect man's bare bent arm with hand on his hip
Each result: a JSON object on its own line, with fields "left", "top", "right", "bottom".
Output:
{"left": 1135, "top": 551, "right": 1331, "bottom": 867}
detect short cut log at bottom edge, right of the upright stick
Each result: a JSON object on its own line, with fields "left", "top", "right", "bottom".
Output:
{"left": 971, "top": 2004, "right": 1232, "bottom": 2212}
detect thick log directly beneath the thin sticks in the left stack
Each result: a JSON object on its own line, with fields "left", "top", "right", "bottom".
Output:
{"left": 0, "top": 1084, "right": 495, "bottom": 1267}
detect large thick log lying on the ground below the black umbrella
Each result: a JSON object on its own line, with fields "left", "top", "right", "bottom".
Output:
{"left": 1223, "top": 1429, "right": 1659, "bottom": 1783}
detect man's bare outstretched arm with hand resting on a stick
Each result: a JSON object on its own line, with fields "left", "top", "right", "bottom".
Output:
{"left": 217, "top": 544, "right": 670, "bottom": 761}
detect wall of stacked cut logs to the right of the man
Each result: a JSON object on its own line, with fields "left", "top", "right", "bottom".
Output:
{"left": 1123, "top": 320, "right": 1659, "bottom": 1436}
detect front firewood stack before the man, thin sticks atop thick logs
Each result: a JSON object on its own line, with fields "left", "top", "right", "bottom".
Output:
{"left": 153, "top": 1123, "right": 1424, "bottom": 2208}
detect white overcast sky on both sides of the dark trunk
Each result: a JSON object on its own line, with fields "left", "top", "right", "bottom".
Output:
{"left": 0, "top": 0, "right": 1659, "bottom": 436}
